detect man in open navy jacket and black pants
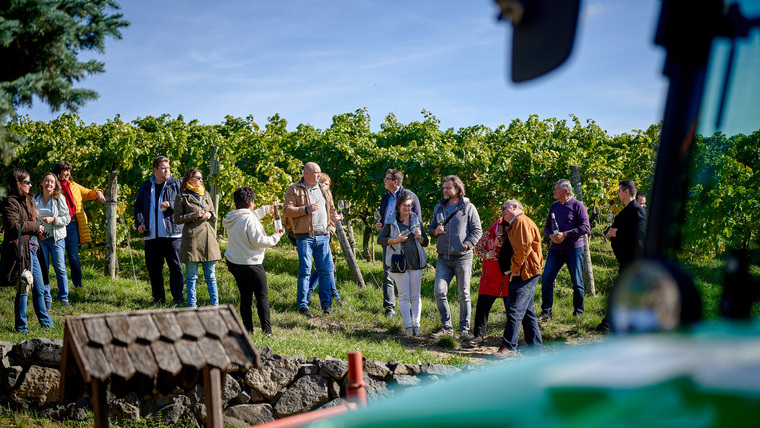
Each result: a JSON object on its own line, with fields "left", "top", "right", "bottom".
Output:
{"left": 134, "top": 156, "right": 185, "bottom": 306}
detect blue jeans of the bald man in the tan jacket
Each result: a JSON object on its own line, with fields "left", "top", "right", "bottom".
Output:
{"left": 296, "top": 235, "right": 335, "bottom": 308}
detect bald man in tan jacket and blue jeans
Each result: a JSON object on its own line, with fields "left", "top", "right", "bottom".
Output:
{"left": 283, "top": 162, "right": 336, "bottom": 318}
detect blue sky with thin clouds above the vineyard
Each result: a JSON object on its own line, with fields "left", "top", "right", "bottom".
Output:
{"left": 19, "top": 0, "right": 667, "bottom": 135}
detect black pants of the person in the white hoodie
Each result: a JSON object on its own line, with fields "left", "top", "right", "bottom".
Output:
{"left": 227, "top": 261, "right": 272, "bottom": 334}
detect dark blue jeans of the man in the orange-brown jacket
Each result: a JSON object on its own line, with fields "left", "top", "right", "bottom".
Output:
{"left": 501, "top": 275, "right": 543, "bottom": 351}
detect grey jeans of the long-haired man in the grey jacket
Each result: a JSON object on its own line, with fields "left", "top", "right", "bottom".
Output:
{"left": 433, "top": 252, "right": 472, "bottom": 333}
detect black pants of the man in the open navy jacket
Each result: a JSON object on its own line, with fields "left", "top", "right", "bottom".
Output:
{"left": 145, "top": 238, "right": 185, "bottom": 303}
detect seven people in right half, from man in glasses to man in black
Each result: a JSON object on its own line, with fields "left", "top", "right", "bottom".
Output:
{"left": 375, "top": 169, "right": 646, "bottom": 357}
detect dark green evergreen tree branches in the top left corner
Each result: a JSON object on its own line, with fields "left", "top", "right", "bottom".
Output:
{"left": 0, "top": 0, "right": 129, "bottom": 163}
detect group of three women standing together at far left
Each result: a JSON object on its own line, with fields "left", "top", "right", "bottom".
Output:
{"left": 0, "top": 161, "right": 106, "bottom": 332}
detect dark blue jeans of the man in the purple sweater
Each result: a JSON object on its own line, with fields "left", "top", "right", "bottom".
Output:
{"left": 541, "top": 247, "right": 583, "bottom": 315}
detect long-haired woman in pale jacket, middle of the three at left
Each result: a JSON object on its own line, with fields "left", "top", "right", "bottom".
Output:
{"left": 34, "top": 172, "right": 71, "bottom": 309}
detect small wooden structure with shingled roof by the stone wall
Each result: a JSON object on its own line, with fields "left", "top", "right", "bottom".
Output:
{"left": 60, "top": 305, "right": 261, "bottom": 428}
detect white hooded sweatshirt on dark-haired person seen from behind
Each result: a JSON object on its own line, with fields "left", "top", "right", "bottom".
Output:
{"left": 222, "top": 205, "right": 280, "bottom": 265}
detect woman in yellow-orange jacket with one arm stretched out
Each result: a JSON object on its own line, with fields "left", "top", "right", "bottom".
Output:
{"left": 53, "top": 161, "right": 106, "bottom": 288}
